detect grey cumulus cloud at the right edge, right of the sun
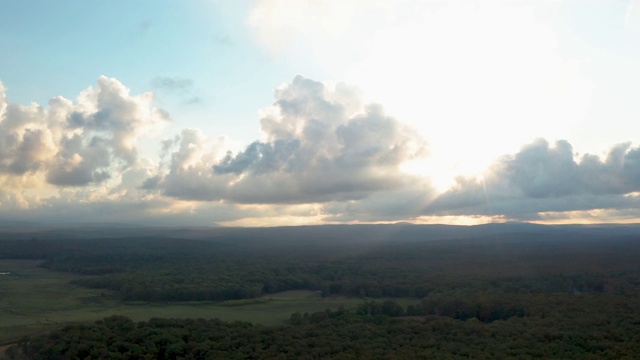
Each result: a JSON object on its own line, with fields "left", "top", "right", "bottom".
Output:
{"left": 432, "top": 139, "right": 640, "bottom": 220}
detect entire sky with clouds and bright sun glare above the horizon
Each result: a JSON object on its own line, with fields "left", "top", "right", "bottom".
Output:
{"left": 0, "top": 0, "right": 640, "bottom": 226}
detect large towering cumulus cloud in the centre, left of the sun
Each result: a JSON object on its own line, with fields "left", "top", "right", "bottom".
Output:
{"left": 147, "top": 76, "right": 430, "bottom": 204}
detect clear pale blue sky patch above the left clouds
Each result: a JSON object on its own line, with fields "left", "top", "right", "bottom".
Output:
{"left": 0, "top": 0, "right": 308, "bottom": 140}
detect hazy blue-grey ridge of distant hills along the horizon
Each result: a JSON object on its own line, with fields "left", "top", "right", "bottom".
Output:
{"left": 0, "top": 221, "right": 640, "bottom": 242}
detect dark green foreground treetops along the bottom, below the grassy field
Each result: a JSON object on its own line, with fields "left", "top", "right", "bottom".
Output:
{"left": 7, "top": 302, "right": 640, "bottom": 359}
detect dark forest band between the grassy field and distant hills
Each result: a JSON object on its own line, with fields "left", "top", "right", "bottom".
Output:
{"left": 0, "top": 233, "right": 640, "bottom": 302}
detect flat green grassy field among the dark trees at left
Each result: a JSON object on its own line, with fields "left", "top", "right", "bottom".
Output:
{"left": 0, "top": 260, "right": 362, "bottom": 345}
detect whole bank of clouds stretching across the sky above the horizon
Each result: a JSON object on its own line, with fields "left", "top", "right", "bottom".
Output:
{"left": 0, "top": 76, "right": 640, "bottom": 225}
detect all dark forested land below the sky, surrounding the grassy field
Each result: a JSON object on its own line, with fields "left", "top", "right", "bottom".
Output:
{"left": 0, "top": 224, "right": 640, "bottom": 359}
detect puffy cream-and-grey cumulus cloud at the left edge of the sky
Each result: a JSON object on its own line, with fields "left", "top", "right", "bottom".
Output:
{"left": 0, "top": 76, "right": 168, "bottom": 186}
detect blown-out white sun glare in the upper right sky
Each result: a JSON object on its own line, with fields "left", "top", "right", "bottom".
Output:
{"left": 249, "top": 1, "right": 593, "bottom": 183}
